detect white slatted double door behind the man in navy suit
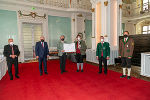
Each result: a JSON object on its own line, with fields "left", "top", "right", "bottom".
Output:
{"left": 22, "top": 23, "right": 42, "bottom": 60}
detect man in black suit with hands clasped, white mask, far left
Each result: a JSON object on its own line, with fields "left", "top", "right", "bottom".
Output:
{"left": 3, "top": 39, "right": 20, "bottom": 80}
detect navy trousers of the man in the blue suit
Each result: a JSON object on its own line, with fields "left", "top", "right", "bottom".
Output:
{"left": 39, "top": 57, "right": 47, "bottom": 73}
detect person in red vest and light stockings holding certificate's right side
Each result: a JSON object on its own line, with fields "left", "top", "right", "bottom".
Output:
{"left": 75, "top": 35, "right": 87, "bottom": 72}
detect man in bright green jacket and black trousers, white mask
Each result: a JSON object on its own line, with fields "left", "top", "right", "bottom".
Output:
{"left": 96, "top": 36, "right": 110, "bottom": 74}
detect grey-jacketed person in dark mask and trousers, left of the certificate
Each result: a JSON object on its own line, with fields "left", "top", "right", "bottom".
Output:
{"left": 57, "top": 35, "right": 67, "bottom": 74}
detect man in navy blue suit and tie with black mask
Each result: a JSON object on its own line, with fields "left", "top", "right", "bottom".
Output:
{"left": 35, "top": 36, "right": 49, "bottom": 76}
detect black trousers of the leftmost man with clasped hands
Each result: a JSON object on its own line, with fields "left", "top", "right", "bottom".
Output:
{"left": 7, "top": 60, "right": 18, "bottom": 77}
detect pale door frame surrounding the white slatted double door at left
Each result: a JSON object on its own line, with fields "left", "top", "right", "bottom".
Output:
{"left": 17, "top": 14, "right": 49, "bottom": 62}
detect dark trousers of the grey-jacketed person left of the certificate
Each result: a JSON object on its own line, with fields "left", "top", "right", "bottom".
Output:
{"left": 59, "top": 53, "right": 67, "bottom": 72}
